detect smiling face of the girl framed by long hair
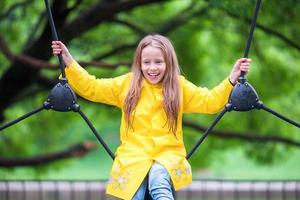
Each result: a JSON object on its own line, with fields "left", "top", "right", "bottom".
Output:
{"left": 141, "top": 45, "right": 166, "bottom": 84}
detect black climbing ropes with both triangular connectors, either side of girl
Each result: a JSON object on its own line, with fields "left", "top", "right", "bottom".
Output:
{"left": 0, "top": 0, "right": 300, "bottom": 173}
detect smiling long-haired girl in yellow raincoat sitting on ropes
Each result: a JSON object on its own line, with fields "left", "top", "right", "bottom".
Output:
{"left": 52, "top": 35, "right": 251, "bottom": 200}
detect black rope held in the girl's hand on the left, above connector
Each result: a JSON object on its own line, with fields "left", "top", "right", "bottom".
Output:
{"left": 45, "top": 0, "right": 66, "bottom": 79}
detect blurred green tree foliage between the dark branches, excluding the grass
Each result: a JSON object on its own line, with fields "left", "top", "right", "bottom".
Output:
{"left": 0, "top": 0, "right": 300, "bottom": 178}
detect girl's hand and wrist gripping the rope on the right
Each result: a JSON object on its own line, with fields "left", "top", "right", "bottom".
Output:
{"left": 229, "top": 58, "right": 251, "bottom": 85}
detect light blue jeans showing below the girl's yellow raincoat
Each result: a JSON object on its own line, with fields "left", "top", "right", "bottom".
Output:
{"left": 132, "top": 162, "right": 174, "bottom": 200}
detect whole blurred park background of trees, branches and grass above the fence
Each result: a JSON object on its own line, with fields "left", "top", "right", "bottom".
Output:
{"left": 0, "top": 0, "right": 300, "bottom": 179}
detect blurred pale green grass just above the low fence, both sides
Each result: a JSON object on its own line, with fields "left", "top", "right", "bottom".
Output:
{"left": 0, "top": 148, "right": 300, "bottom": 180}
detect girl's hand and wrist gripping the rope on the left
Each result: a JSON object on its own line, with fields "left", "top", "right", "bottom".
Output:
{"left": 51, "top": 41, "right": 74, "bottom": 66}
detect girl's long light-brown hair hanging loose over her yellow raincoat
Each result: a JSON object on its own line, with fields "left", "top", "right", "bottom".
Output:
{"left": 124, "top": 34, "right": 180, "bottom": 134}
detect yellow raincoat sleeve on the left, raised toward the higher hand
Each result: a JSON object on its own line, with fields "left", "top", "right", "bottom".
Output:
{"left": 65, "top": 61, "right": 129, "bottom": 107}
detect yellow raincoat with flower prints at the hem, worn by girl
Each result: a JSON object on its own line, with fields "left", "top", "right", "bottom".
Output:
{"left": 66, "top": 62, "right": 232, "bottom": 200}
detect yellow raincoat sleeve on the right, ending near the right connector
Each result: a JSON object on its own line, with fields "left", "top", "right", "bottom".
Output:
{"left": 182, "top": 77, "right": 233, "bottom": 114}
